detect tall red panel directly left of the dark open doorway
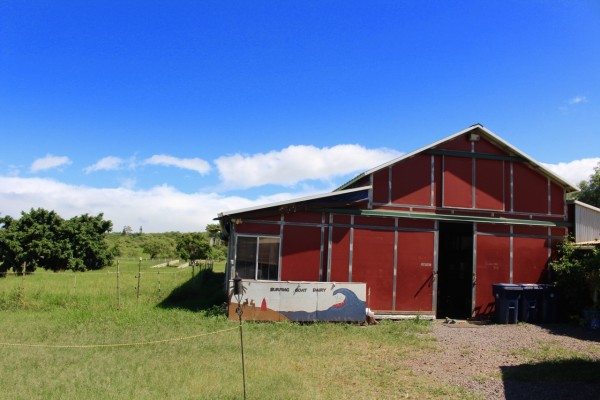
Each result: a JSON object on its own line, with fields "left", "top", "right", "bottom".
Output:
{"left": 396, "top": 232, "right": 434, "bottom": 311}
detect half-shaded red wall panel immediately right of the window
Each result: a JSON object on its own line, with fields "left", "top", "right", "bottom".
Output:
{"left": 281, "top": 226, "right": 321, "bottom": 281}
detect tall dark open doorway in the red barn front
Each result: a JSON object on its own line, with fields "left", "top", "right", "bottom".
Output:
{"left": 436, "top": 222, "right": 473, "bottom": 319}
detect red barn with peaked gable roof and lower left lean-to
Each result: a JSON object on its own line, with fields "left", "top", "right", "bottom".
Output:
{"left": 219, "top": 124, "right": 576, "bottom": 318}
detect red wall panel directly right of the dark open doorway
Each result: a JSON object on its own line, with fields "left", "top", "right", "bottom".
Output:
{"left": 475, "top": 236, "right": 510, "bottom": 316}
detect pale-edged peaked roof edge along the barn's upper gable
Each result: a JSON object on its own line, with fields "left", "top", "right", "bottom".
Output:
{"left": 336, "top": 124, "right": 579, "bottom": 192}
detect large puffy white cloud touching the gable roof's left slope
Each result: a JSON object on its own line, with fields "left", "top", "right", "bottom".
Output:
{"left": 215, "top": 144, "right": 401, "bottom": 188}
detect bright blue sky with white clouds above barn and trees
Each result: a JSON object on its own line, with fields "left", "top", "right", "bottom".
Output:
{"left": 0, "top": 1, "right": 600, "bottom": 231}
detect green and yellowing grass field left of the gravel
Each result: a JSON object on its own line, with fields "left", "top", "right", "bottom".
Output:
{"left": 0, "top": 259, "right": 478, "bottom": 399}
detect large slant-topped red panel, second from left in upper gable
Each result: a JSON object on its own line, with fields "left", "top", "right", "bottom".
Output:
{"left": 392, "top": 154, "right": 431, "bottom": 206}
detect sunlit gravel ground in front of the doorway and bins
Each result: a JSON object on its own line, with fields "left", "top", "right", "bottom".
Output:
{"left": 410, "top": 321, "right": 600, "bottom": 400}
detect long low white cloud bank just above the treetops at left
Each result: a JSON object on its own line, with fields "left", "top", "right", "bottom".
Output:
{"left": 0, "top": 176, "right": 313, "bottom": 232}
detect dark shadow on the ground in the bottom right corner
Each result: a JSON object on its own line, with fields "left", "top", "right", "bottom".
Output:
{"left": 500, "top": 358, "right": 600, "bottom": 400}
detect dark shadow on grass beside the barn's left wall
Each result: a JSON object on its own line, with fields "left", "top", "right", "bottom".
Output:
{"left": 158, "top": 270, "right": 227, "bottom": 314}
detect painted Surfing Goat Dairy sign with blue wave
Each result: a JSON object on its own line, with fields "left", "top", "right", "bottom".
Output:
{"left": 229, "top": 280, "right": 367, "bottom": 321}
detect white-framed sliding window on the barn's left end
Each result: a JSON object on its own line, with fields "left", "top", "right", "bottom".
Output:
{"left": 235, "top": 235, "right": 279, "bottom": 281}
